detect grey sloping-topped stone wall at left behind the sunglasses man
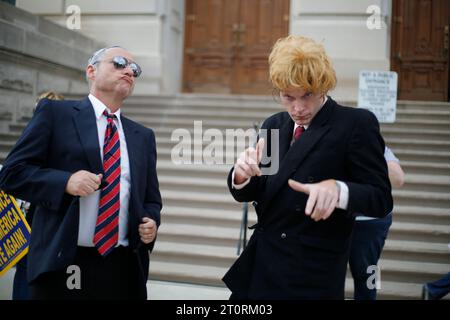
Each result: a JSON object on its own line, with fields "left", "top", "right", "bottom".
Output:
{"left": 0, "top": 2, "right": 103, "bottom": 122}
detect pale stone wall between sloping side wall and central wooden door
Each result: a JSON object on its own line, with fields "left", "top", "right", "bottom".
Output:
{"left": 17, "top": 0, "right": 184, "bottom": 95}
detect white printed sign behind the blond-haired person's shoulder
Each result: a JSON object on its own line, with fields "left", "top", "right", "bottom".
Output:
{"left": 358, "top": 71, "right": 397, "bottom": 123}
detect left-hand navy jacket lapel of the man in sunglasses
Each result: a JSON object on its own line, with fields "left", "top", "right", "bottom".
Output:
{"left": 73, "top": 97, "right": 103, "bottom": 173}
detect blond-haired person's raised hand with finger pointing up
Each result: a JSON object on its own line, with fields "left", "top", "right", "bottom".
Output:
{"left": 234, "top": 138, "right": 264, "bottom": 185}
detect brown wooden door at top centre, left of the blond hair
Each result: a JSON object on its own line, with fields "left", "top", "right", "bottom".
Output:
{"left": 183, "top": 0, "right": 289, "bottom": 95}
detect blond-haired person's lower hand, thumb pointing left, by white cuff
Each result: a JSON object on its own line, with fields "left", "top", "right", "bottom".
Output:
{"left": 288, "top": 179, "right": 339, "bottom": 221}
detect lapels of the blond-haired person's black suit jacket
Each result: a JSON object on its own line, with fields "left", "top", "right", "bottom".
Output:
{"left": 264, "top": 98, "right": 334, "bottom": 208}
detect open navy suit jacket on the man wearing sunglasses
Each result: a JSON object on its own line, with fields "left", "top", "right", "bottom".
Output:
{"left": 0, "top": 97, "right": 162, "bottom": 298}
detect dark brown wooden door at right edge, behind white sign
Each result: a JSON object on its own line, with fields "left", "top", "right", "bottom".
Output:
{"left": 391, "top": 0, "right": 450, "bottom": 101}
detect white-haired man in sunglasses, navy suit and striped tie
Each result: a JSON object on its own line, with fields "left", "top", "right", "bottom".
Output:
{"left": 0, "top": 47, "right": 162, "bottom": 299}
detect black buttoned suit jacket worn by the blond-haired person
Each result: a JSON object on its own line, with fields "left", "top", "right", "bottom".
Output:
{"left": 223, "top": 98, "right": 392, "bottom": 299}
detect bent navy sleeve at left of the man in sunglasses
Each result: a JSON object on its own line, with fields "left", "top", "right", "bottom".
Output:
{"left": 0, "top": 99, "right": 71, "bottom": 210}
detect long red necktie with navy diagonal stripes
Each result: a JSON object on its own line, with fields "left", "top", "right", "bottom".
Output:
{"left": 94, "top": 110, "right": 120, "bottom": 256}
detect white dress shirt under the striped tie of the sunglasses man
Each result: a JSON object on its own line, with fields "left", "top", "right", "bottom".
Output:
{"left": 78, "top": 94, "right": 131, "bottom": 247}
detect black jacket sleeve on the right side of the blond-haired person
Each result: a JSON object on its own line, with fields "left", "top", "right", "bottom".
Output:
{"left": 345, "top": 110, "right": 393, "bottom": 217}
